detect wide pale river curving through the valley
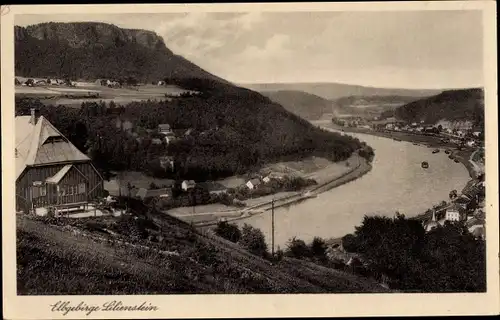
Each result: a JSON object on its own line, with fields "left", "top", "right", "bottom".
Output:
{"left": 237, "top": 127, "right": 470, "bottom": 249}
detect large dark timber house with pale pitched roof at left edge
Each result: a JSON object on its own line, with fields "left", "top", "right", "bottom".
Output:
{"left": 15, "top": 109, "right": 104, "bottom": 214}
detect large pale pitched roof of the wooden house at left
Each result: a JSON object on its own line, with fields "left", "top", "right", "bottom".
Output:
{"left": 15, "top": 116, "right": 90, "bottom": 179}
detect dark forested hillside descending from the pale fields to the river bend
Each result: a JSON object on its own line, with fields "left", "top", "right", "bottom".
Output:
{"left": 16, "top": 80, "right": 372, "bottom": 180}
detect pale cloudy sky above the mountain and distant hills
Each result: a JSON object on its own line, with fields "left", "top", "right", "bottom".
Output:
{"left": 15, "top": 10, "right": 484, "bottom": 89}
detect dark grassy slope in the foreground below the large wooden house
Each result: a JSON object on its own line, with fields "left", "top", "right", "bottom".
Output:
{"left": 17, "top": 201, "right": 389, "bottom": 295}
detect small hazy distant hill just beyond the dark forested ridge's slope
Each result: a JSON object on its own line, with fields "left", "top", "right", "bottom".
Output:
{"left": 261, "top": 90, "right": 333, "bottom": 120}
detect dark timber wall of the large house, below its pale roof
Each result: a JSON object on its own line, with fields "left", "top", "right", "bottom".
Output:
{"left": 16, "top": 162, "right": 104, "bottom": 211}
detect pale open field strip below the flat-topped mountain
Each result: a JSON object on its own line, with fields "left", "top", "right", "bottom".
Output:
{"left": 15, "top": 83, "right": 188, "bottom": 107}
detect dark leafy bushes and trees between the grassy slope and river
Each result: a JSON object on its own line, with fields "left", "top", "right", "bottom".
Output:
{"left": 215, "top": 212, "right": 486, "bottom": 292}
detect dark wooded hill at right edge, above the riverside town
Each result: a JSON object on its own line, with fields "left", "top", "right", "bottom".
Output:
{"left": 394, "top": 88, "right": 484, "bottom": 126}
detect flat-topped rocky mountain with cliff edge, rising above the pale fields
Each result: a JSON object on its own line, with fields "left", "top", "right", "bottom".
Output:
{"left": 15, "top": 22, "right": 229, "bottom": 83}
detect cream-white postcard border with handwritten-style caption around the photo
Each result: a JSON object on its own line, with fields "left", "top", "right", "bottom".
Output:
{"left": 1, "top": 1, "right": 499, "bottom": 319}
